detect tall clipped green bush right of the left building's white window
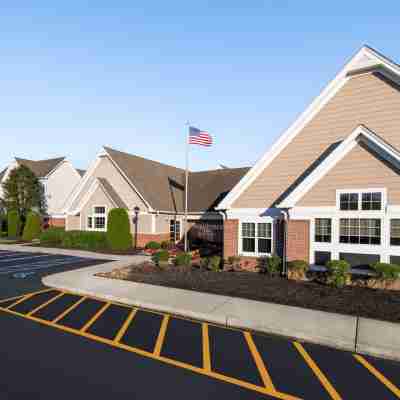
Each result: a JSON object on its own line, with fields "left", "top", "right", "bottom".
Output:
{"left": 107, "top": 208, "right": 132, "bottom": 250}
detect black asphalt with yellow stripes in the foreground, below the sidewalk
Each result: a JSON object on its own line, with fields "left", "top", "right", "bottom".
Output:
{"left": 0, "top": 289, "right": 400, "bottom": 400}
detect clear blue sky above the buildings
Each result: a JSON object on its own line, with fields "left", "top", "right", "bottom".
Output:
{"left": 0, "top": 0, "right": 400, "bottom": 170}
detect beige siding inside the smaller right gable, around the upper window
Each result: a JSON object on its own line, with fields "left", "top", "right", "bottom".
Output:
{"left": 296, "top": 146, "right": 400, "bottom": 207}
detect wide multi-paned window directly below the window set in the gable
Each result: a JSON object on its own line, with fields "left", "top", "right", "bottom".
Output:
{"left": 339, "top": 218, "right": 381, "bottom": 244}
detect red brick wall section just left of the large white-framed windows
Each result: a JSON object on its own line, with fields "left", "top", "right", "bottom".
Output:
{"left": 286, "top": 220, "right": 310, "bottom": 262}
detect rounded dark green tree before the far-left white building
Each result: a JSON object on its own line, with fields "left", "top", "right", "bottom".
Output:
{"left": 3, "top": 165, "right": 47, "bottom": 221}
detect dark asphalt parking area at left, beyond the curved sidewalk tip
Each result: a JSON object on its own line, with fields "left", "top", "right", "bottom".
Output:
{"left": 0, "top": 250, "right": 106, "bottom": 299}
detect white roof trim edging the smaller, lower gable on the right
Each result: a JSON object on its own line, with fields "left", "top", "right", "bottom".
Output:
{"left": 278, "top": 125, "right": 400, "bottom": 208}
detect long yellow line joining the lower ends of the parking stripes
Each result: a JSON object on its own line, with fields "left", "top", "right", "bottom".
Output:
{"left": 2, "top": 308, "right": 301, "bottom": 400}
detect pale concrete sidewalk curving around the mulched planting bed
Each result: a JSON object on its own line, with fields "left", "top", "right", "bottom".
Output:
{"left": 0, "top": 245, "right": 400, "bottom": 359}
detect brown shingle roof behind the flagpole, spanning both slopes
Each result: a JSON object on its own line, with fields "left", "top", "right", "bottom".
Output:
{"left": 104, "top": 147, "right": 249, "bottom": 212}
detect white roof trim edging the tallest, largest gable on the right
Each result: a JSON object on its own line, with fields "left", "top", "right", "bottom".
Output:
{"left": 217, "top": 46, "right": 400, "bottom": 210}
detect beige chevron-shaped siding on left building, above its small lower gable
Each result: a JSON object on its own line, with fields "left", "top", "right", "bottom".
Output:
{"left": 71, "top": 157, "right": 147, "bottom": 211}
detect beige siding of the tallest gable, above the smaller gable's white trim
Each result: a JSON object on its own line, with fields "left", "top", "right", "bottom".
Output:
{"left": 233, "top": 74, "right": 400, "bottom": 208}
